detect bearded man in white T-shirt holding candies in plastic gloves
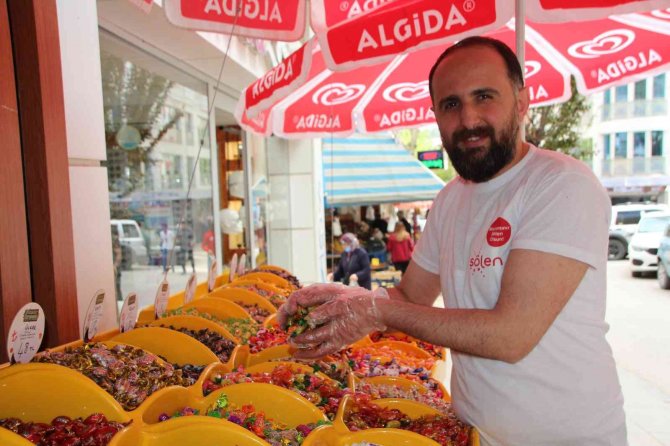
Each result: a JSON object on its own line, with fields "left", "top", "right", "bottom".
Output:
{"left": 277, "top": 37, "right": 627, "bottom": 446}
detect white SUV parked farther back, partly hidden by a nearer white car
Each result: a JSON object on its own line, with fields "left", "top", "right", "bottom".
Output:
{"left": 608, "top": 203, "right": 670, "bottom": 260}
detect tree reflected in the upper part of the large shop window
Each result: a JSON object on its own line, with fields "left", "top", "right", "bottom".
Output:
{"left": 101, "top": 53, "right": 182, "bottom": 196}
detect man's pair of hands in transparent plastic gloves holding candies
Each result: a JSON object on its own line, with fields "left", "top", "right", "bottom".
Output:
{"left": 278, "top": 284, "right": 388, "bottom": 359}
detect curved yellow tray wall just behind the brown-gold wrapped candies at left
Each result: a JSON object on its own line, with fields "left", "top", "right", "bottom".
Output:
{"left": 112, "top": 327, "right": 219, "bottom": 365}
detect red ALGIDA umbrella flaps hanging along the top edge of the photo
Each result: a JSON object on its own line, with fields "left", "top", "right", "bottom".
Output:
{"left": 164, "top": 0, "right": 670, "bottom": 70}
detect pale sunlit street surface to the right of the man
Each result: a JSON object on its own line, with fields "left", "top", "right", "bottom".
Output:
{"left": 606, "top": 260, "right": 670, "bottom": 446}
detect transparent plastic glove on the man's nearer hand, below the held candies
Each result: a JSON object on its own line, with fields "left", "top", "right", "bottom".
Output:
{"left": 291, "top": 288, "right": 388, "bottom": 359}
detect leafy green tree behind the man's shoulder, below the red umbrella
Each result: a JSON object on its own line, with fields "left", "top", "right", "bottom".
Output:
{"left": 526, "top": 78, "right": 593, "bottom": 161}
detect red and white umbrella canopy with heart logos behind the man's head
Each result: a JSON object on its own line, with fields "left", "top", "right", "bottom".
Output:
{"left": 236, "top": 11, "right": 670, "bottom": 138}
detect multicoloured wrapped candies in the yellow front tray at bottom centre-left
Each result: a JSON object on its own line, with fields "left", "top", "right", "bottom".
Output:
{"left": 158, "top": 394, "right": 327, "bottom": 446}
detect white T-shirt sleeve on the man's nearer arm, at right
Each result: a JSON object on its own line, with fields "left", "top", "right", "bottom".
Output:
{"left": 511, "top": 172, "right": 611, "bottom": 268}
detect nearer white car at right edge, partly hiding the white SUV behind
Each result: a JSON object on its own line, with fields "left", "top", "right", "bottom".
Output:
{"left": 628, "top": 212, "right": 670, "bottom": 277}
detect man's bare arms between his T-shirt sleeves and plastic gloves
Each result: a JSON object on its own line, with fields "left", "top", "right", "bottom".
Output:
{"left": 377, "top": 249, "right": 588, "bottom": 363}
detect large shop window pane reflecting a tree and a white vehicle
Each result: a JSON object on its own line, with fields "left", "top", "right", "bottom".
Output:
{"left": 100, "top": 31, "right": 214, "bottom": 307}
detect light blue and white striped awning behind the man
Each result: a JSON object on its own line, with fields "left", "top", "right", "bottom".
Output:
{"left": 322, "top": 135, "right": 444, "bottom": 207}
